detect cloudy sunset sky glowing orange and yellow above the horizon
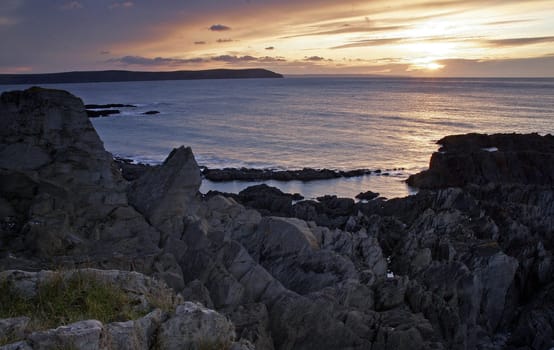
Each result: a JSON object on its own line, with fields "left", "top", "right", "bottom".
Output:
{"left": 0, "top": 0, "right": 554, "bottom": 77}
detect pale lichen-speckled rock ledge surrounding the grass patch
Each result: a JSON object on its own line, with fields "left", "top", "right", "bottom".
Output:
{"left": 0, "top": 269, "right": 249, "bottom": 350}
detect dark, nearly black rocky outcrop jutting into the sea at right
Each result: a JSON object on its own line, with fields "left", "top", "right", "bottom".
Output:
{"left": 407, "top": 134, "right": 554, "bottom": 188}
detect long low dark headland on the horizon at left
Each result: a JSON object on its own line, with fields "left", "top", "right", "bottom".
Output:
{"left": 0, "top": 69, "right": 283, "bottom": 85}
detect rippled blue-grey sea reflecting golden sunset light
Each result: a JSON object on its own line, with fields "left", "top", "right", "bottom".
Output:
{"left": 0, "top": 76, "right": 554, "bottom": 198}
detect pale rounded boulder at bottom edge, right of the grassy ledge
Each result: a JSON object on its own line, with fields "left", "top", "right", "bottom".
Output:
{"left": 158, "top": 302, "right": 235, "bottom": 350}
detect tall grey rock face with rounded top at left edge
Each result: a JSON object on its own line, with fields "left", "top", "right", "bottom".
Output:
{"left": 0, "top": 88, "right": 158, "bottom": 258}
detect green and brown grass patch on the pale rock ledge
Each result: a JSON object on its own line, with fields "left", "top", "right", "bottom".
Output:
{"left": 0, "top": 272, "right": 144, "bottom": 330}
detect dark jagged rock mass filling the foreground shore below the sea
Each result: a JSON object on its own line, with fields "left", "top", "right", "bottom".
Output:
{"left": 0, "top": 88, "right": 554, "bottom": 350}
